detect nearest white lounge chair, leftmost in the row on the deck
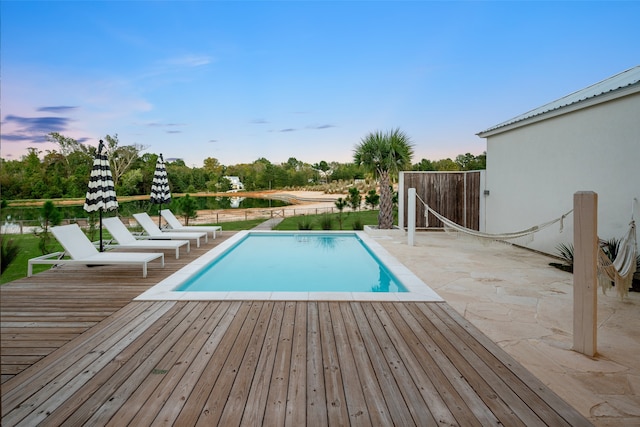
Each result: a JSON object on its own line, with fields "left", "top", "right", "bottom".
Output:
{"left": 27, "top": 224, "right": 164, "bottom": 277}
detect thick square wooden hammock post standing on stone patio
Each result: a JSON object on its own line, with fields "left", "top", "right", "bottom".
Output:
{"left": 573, "top": 191, "right": 598, "bottom": 357}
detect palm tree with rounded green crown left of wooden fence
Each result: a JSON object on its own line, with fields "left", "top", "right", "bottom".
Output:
{"left": 353, "top": 128, "right": 413, "bottom": 229}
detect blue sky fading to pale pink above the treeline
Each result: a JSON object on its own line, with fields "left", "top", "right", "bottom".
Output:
{"left": 0, "top": 1, "right": 640, "bottom": 167}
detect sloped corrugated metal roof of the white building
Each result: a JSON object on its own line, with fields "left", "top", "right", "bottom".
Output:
{"left": 478, "top": 65, "right": 640, "bottom": 136}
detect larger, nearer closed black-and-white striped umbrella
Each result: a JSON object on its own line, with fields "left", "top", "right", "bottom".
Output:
{"left": 84, "top": 140, "right": 118, "bottom": 252}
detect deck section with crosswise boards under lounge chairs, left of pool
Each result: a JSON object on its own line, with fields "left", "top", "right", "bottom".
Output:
{"left": 0, "top": 237, "right": 228, "bottom": 382}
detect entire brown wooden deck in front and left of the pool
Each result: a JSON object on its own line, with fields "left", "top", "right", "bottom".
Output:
{"left": 0, "top": 239, "right": 590, "bottom": 426}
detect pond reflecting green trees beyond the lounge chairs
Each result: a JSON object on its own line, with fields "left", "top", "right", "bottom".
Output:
{"left": 1, "top": 197, "right": 289, "bottom": 223}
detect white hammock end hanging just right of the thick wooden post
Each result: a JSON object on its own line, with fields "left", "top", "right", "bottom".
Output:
{"left": 598, "top": 217, "right": 638, "bottom": 298}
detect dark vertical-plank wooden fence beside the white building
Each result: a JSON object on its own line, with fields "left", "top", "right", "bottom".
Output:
{"left": 398, "top": 171, "right": 482, "bottom": 230}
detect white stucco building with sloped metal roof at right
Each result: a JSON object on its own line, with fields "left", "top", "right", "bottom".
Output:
{"left": 478, "top": 66, "right": 640, "bottom": 254}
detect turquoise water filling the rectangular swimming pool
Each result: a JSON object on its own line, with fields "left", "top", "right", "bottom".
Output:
{"left": 175, "top": 233, "right": 407, "bottom": 292}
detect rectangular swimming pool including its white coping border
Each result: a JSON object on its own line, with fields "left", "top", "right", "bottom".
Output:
{"left": 136, "top": 231, "right": 441, "bottom": 301}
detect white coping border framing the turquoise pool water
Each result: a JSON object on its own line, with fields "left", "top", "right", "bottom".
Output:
{"left": 135, "top": 230, "right": 444, "bottom": 302}
